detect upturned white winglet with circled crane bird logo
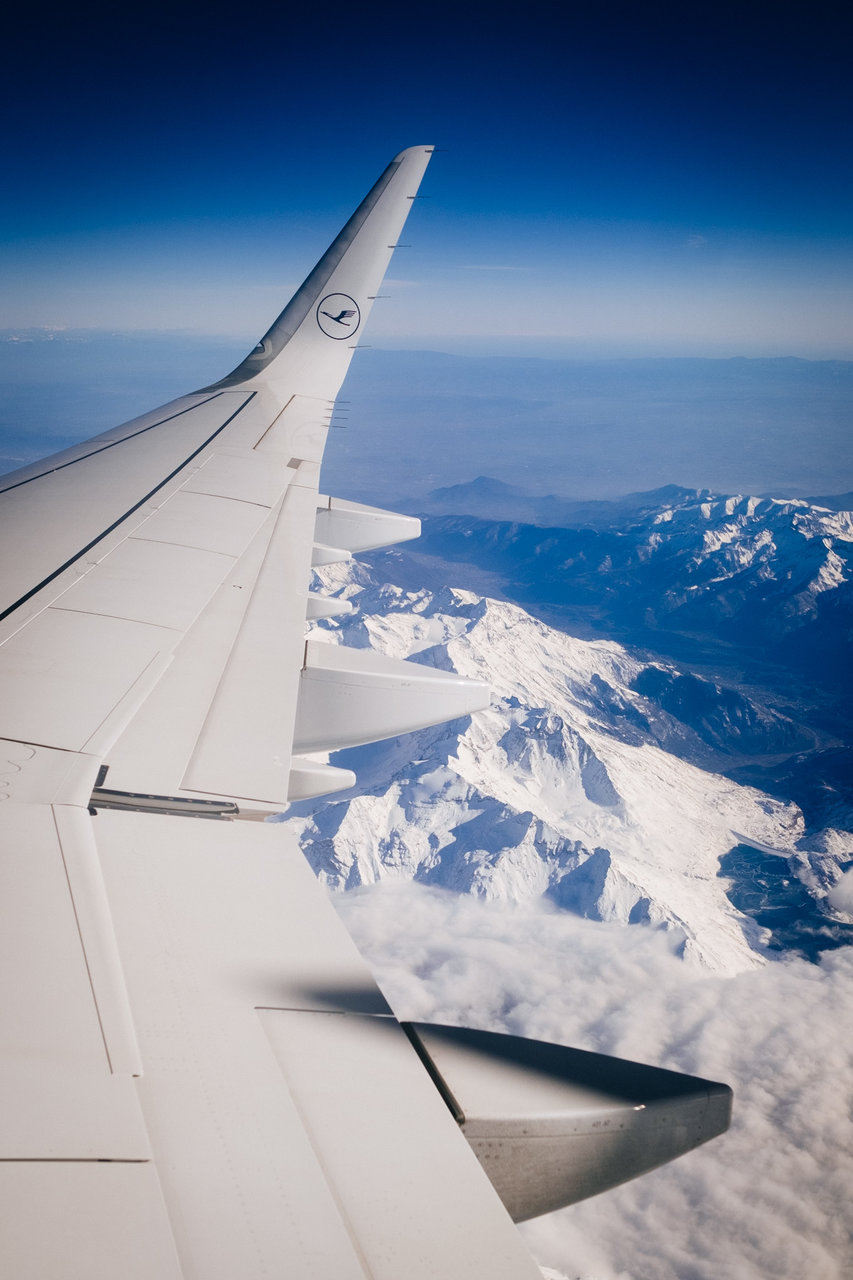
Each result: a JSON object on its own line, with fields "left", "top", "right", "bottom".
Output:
{"left": 205, "top": 146, "right": 433, "bottom": 397}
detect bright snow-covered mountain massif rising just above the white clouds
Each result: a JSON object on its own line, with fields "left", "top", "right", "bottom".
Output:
{"left": 288, "top": 564, "right": 853, "bottom": 973}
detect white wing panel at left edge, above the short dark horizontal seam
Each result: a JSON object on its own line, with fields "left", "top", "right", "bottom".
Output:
{"left": 0, "top": 804, "right": 151, "bottom": 1161}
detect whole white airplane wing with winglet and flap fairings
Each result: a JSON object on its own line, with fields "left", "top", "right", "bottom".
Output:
{"left": 0, "top": 147, "right": 729, "bottom": 1280}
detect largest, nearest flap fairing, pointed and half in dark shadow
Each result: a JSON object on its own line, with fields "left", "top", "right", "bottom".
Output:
{"left": 407, "top": 1023, "right": 731, "bottom": 1222}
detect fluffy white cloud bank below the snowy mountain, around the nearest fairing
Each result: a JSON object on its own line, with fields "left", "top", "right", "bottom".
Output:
{"left": 336, "top": 883, "right": 853, "bottom": 1280}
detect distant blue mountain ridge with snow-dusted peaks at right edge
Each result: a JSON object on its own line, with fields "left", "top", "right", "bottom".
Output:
{"left": 404, "top": 485, "right": 853, "bottom": 718}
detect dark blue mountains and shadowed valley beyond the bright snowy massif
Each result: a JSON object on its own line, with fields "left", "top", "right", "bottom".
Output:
{"left": 363, "top": 479, "right": 853, "bottom": 822}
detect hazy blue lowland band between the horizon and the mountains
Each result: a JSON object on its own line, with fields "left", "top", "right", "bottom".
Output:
{"left": 0, "top": 332, "right": 853, "bottom": 506}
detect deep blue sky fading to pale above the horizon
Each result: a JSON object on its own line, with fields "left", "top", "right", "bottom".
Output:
{"left": 0, "top": 0, "right": 853, "bottom": 358}
